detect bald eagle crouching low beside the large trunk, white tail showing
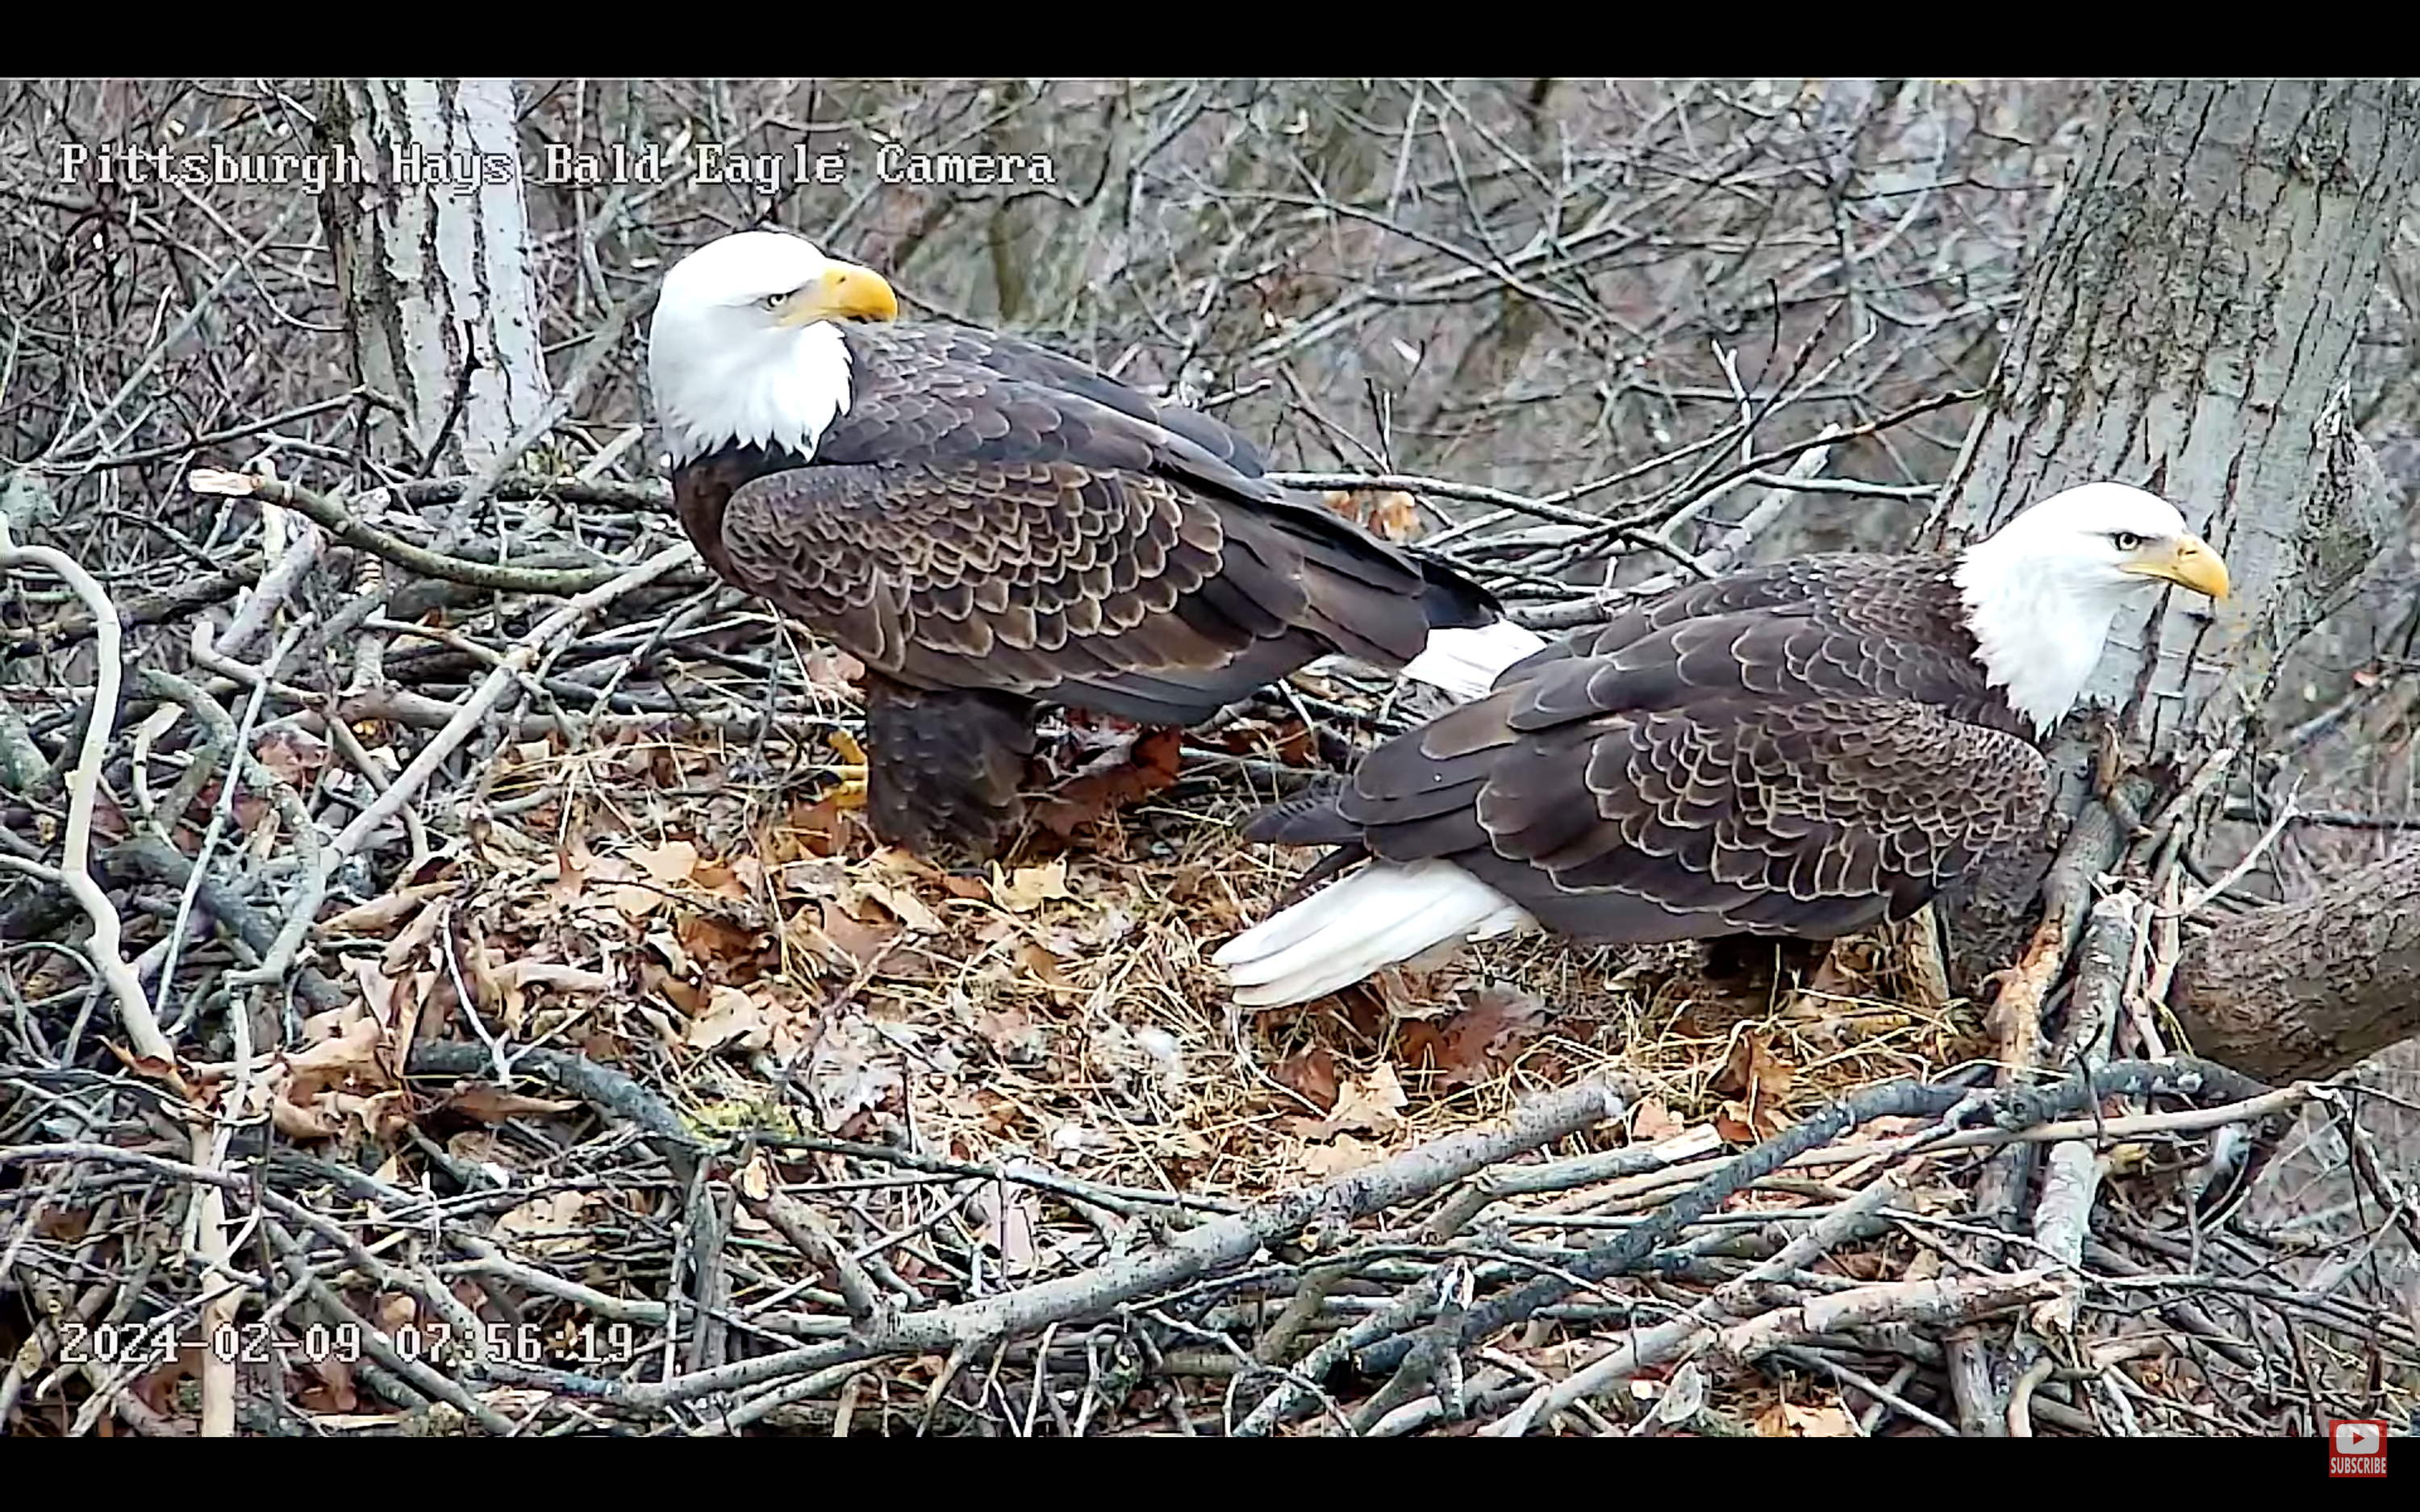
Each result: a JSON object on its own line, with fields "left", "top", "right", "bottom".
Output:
{"left": 1215, "top": 484, "right": 2226, "bottom": 1006}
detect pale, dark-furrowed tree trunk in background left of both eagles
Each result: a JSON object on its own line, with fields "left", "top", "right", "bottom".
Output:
{"left": 319, "top": 80, "right": 549, "bottom": 472}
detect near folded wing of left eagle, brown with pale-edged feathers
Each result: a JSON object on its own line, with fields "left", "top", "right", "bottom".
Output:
{"left": 719, "top": 462, "right": 1428, "bottom": 723}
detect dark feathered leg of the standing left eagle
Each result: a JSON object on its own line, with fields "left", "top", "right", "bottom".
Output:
{"left": 866, "top": 673, "right": 1033, "bottom": 861}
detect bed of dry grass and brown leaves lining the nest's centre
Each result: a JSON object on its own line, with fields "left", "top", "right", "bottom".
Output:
{"left": 397, "top": 687, "right": 1984, "bottom": 1214}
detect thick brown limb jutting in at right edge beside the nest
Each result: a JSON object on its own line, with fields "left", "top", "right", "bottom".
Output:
{"left": 2168, "top": 844, "right": 2420, "bottom": 1084}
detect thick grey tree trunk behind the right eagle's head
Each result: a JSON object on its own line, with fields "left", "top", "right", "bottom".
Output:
{"left": 1943, "top": 80, "right": 2420, "bottom": 982}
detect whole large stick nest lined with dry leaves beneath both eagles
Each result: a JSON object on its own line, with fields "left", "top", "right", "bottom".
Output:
{"left": 0, "top": 467, "right": 2381, "bottom": 1435}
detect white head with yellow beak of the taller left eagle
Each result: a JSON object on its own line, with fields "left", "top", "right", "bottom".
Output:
{"left": 646, "top": 230, "right": 900, "bottom": 464}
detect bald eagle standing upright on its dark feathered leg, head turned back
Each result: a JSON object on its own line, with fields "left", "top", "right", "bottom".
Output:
{"left": 649, "top": 232, "right": 1498, "bottom": 859}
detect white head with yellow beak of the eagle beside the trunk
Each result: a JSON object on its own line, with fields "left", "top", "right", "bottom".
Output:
{"left": 1958, "top": 484, "right": 2226, "bottom": 731}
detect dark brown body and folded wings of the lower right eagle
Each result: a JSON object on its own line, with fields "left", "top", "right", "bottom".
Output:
{"left": 1258, "top": 559, "right": 2050, "bottom": 941}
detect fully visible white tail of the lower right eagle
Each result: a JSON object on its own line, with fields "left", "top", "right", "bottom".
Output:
{"left": 1210, "top": 861, "right": 1537, "bottom": 1009}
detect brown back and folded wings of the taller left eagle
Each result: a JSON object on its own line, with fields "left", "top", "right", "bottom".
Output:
{"left": 678, "top": 327, "right": 1496, "bottom": 723}
